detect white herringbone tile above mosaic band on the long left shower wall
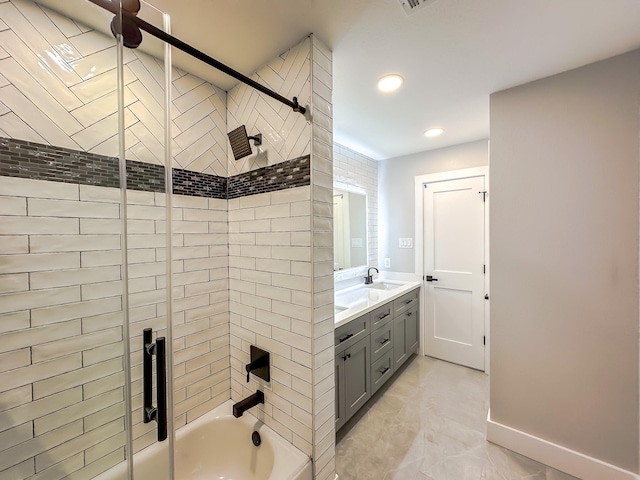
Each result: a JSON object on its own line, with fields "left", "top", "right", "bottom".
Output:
{"left": 0, "top": 0, "right": 227, "bottom": 176}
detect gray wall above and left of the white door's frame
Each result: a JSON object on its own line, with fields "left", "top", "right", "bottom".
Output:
{"left": 378, "top": 140, "right": 489, "bottom": 273}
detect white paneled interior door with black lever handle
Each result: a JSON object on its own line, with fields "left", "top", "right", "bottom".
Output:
{"left": 423, "top": 176, "right": 485, "bottom": 370}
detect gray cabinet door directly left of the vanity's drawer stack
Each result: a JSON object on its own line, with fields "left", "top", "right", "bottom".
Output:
{"left": 342, "top": 337, "right": 371, "bottom": 420}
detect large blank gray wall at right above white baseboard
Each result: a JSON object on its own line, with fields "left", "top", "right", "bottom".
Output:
{"left": 490, "top": 51, "right": 640, "bottom": 472}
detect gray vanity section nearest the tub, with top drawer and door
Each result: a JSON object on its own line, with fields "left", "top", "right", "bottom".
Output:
{"left": 335, "top": 314, "right": 371, "bottom": 430}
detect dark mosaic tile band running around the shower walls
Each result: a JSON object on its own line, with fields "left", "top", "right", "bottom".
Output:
{"left": 0, "top": 137, "right": 311, "bottom": 199}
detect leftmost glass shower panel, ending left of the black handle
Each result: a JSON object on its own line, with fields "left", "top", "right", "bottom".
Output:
{"left": 0, "top": 0, "right": 136, "bottom": 480}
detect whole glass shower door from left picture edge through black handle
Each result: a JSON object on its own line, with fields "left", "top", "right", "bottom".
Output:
{"left": 0, "top": 0, "right": 173, "bottom": 480}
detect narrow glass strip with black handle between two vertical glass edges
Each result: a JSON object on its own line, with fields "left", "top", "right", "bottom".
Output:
{"left": 115, "top": 2, "right": 174, "bottom": 480}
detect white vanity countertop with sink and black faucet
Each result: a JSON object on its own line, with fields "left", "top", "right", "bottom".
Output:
{"left": 334, "top": 280, "right": 420, "bottom": 328}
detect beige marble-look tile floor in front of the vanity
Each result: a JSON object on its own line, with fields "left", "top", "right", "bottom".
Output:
{"left": 336, "top": 356, "right": 576, "bottom": 480}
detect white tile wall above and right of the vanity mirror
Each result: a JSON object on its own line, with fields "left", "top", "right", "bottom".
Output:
{"left": 333, "top": 143, "right": 378, "bottom": 266}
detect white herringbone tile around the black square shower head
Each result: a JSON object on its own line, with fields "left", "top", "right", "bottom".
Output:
{"left": 228, "top": 37, "right": 311, "bottom": 176}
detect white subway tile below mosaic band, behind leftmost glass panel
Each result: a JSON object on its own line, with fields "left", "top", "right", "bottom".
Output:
{"left": 0, "top": 173, "right": 129, "bottom": 478}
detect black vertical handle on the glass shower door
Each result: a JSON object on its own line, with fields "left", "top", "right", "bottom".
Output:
{"left": 142, "top": 328, "right": 167, "bottom": 442}
